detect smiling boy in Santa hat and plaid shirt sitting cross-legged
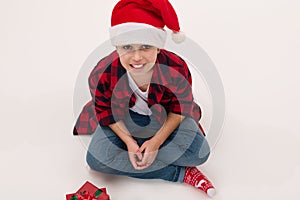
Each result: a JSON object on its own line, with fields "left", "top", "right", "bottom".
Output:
{"left": 74, "top": 0, "right": 215, "bottom": 196}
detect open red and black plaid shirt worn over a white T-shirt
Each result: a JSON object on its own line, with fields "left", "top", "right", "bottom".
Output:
{"left": 73, "top": 50, "right": 204, "bottom": 135}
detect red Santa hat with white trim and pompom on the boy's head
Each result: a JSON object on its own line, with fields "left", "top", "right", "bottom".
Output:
{"left": 109, "top": 0, "right": 185, "bottom": 48}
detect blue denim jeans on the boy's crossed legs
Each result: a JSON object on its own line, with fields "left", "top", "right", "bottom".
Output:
{"left": 86, "top": 111, "right": 210, "bottom": 182}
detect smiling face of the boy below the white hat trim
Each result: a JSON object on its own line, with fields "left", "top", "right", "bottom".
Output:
{"left": 117, "top": 44, "right": 159, "bottom": 75}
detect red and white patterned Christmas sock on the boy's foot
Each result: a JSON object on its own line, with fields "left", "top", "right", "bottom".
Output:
{"left": 183, "top": 167, "right": 215, "bottom": 197}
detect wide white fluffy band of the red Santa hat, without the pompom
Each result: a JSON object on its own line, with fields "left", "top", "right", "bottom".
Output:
{"left": 109, "top": 22, "right": 167, "bottom": 48}
